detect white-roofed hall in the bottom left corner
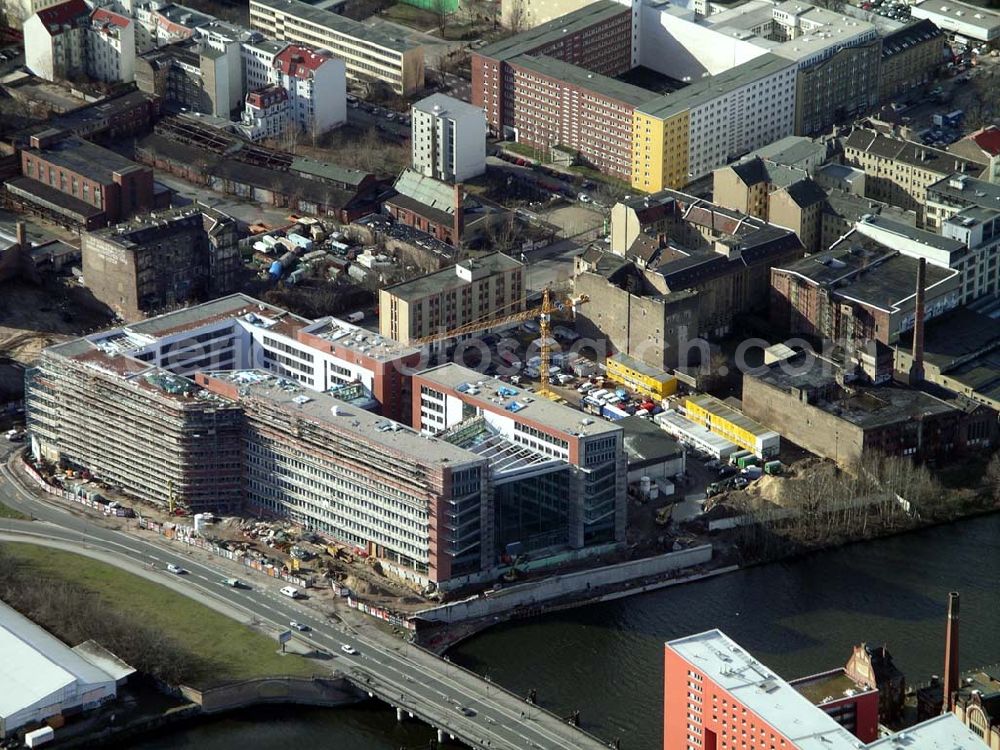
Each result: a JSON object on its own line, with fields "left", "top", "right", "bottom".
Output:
{"left": 0, "top": 601, "right": 135, "bottom": 740}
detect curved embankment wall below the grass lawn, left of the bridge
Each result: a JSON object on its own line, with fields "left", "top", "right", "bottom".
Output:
{"left": 181, "top": 677, "right": 360, "bottom": 714}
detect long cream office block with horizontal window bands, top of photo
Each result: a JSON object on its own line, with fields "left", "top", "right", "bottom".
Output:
{"left": 250, "top": 0, "right": 424, "bottom": 96}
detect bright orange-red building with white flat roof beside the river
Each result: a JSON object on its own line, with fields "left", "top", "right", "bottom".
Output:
{"left": 663, "top": 630, "right": 983, "bottom": 750}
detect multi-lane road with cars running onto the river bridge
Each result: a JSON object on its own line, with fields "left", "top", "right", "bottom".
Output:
{"left": 0, "top": 450, "right": 606, "bottom": 750}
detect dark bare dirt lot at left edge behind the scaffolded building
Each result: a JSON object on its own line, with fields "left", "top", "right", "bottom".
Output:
{"left": 0, "top": 281, "right": 110, "bottom": 364}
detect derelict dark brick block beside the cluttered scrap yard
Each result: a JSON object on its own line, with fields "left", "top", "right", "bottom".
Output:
{"left": 81, "top": 206, "right": 242, "bottom": 320}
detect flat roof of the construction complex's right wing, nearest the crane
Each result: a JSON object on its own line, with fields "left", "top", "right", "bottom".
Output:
{"left": 415, "top": 362, "right": 621, "bottom": 437}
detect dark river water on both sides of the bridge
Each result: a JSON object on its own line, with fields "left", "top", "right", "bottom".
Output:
{"left": 136, "top": 514, "right": 1000, "bottom": 750}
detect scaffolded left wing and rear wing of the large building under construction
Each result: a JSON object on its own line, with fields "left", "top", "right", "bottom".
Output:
{"left": 25, "top": 294, "right": 420, "bottom": 513}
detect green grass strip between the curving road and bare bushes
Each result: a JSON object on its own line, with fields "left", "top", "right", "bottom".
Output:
{"left": 3, "top": 544, "right": 320, "bottom": 687}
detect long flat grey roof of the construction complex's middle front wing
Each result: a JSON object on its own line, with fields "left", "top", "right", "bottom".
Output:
{"left": 204, "top": 370, "right": 480, "bottom": 466}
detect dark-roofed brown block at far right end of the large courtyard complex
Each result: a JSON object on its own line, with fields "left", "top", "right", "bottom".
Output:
{"left": 879, "top": 19, "right": 945, "bottom": 102}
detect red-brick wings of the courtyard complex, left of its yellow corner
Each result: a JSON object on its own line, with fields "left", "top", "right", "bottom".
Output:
{"left": 472, "top": 0, "right": 640, "bottom": 178}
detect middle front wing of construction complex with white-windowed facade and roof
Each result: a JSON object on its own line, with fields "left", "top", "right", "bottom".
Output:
{"left": 196, "top": 370, "right": 489, "bottom": 590}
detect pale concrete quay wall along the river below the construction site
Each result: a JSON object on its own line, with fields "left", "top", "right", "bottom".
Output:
{"left": 416, "top": 544, "right": 712, "bottom": 623}
